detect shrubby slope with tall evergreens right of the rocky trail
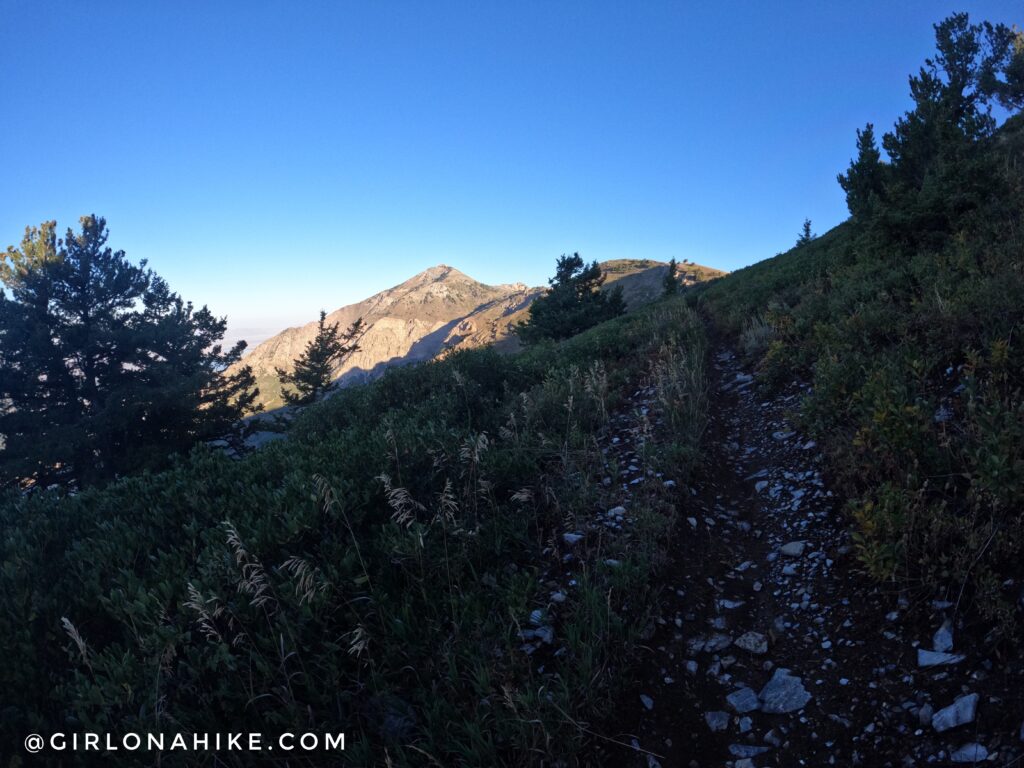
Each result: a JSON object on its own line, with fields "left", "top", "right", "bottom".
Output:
{"left": 701, "top": 14, "right": 1024, "bottom": 633}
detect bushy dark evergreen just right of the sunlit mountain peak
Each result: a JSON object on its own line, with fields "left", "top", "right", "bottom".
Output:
{"left": 516, "top": 253, "right": 626, "bottom": 344}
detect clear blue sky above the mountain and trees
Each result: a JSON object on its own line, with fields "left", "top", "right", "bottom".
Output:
{"left": 0, "top": 0, "right": 1024, "bottom": 335}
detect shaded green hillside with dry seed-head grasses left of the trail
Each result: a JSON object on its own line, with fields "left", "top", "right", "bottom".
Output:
{"left": 0, "top": 300, "right": 705, "bottom": 766}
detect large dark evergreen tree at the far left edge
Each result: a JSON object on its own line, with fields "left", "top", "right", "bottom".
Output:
{"left": 0, "top": 216, "right": 258, "bottom": 485}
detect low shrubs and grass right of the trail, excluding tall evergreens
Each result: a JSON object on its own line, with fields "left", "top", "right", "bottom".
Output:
{"left": 692, "top": 117, "right": 1024, "bottom": 637}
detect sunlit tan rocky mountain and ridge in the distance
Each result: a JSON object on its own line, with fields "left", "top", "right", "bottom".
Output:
{"left": 239, "top": 259, "right": 724, "bottom": 409}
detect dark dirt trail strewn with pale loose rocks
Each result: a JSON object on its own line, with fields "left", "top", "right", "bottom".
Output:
{"left": 604, "top": 347, "right": 1024, "bottom": 768}
